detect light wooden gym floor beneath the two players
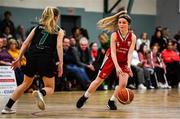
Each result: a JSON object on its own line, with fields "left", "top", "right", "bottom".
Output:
{"left": 0, "top": 89, "right": 180, "bottom": 119}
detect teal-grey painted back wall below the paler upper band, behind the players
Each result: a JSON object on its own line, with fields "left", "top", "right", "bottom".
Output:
{"left": 0, "top": 6, "right": 156, "bottom": 41}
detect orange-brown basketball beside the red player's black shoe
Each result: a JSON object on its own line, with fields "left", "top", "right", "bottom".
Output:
{"left": 116, "top": 88, "right": 134, "bottom": 105}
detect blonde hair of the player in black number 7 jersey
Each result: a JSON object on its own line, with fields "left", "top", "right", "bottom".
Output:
{"left": 39, "top": 6, "right": 59, "bottom": 33}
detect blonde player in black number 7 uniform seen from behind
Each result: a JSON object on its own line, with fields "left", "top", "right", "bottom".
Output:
{"left": 1, "top": 7, "right": 64, "bottom": 114}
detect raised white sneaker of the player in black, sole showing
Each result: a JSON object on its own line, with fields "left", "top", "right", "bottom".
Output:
{"left": 32, "top": 90, "right": 45, "bottom": 110}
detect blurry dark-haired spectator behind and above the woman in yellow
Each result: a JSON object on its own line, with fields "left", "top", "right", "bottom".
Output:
{"left": 16, "top": 25, "right": 26, "bottom": 47}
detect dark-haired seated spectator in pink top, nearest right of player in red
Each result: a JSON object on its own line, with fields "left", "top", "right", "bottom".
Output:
{"left": 138, "top": 43, "right": 154, "bottom": 89}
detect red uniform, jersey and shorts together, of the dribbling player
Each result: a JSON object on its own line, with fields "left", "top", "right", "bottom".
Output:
{"left": 98, "top": 30, "right": 132, "bottom": 79}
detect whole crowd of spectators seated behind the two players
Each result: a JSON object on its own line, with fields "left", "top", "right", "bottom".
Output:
{"left": 0, "top": 11, "right": 180, "bottom": 91}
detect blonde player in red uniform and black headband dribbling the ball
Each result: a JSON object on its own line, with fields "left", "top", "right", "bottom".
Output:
{"left": 76, "top": 8, "right": 136, "bottom": 110}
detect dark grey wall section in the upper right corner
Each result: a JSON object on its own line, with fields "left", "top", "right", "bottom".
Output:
{"left": 156, "top": 0, "right": 180, "bottom": 37}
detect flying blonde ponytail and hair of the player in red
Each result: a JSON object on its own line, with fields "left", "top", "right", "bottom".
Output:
{"left": 97, "top": 8, "right": 130, "bottom": 32}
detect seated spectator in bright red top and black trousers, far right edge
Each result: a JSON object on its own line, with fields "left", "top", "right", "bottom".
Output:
{"left": 162, "top": 40, "right": 180, "bottom": 88}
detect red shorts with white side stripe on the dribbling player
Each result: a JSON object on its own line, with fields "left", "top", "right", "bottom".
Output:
{"left": 98, "top": 55, "right": 129, "bottom": 79}
